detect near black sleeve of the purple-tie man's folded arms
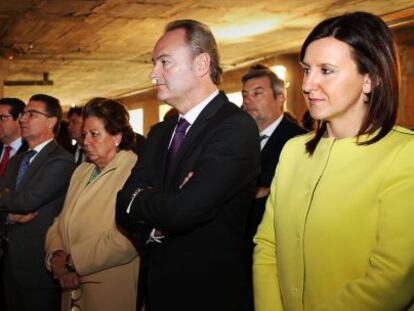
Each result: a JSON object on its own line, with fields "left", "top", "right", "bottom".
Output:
{"left": 117, "top": 114, "right": 259, "bottom": 233}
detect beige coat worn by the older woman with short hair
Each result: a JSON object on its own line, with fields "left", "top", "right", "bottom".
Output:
{"left": 46, "top": 151, "right": 139, "bottom": 311}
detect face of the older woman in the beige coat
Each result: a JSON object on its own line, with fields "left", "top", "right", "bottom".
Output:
{"left": 82, "top": 117, "right": 122, "bottom": 169}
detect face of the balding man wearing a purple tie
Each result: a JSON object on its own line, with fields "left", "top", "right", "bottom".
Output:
{"left": 150, "top": 29, "right": 198, "bottom": 109}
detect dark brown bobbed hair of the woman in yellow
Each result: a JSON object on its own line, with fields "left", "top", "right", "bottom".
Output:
{"left": 300, "top": 12, "right": 399, "bottom": 154}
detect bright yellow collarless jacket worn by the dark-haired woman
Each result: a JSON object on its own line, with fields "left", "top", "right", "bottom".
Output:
{"left": 253, "top": 127, "right": 414, "bottom": 311}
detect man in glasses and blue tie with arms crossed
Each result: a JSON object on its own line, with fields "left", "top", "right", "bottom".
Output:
{"left": 0, "top": 94, "right": 74, "bottom": 311}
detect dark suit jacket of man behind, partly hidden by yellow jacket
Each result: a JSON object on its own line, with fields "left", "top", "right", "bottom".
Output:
{"left": 248, "top": 117, "right": 307, "bottom": 246}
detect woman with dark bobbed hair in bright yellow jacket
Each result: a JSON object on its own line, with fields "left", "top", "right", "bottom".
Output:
{"left": 254, "top": 12, "right": 414, "bottom": 311}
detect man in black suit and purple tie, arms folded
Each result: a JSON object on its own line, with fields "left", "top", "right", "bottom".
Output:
{"left": 117, "top": 20, "right": 259, "bottom": 311}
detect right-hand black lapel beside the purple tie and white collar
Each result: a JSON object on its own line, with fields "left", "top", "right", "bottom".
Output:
{"left": 164, "top": 92, "right": 228, "bottom": 185}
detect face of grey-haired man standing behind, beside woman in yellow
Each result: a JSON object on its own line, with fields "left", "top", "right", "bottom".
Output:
{"left": 242, "top": 77, "right": 285, "bottom": 130}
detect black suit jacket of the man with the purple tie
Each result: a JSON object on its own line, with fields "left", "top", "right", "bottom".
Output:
{"left": 117, "top": 93, "right": 260, "bottom": 311}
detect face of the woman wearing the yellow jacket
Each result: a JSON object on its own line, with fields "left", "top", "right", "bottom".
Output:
{"left": 302, "top": 37, "right": 371, "bottom": 134}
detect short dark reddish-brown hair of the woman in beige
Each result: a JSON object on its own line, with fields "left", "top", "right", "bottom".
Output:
{"left": 82, "top": 97, "right": 135, "bottom": 150}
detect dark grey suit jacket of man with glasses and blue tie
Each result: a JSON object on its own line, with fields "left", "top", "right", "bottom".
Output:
{"left": 0, "top": 141, "right": 75, "bottom": 289}
